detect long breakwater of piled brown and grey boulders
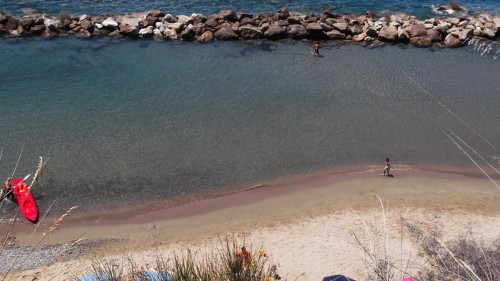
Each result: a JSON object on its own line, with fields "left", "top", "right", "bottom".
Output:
{"left": 0, "top": 8, "right": 500, "bottom": 47}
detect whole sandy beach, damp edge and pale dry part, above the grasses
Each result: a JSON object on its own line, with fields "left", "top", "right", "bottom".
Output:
{"left": 2, "top": 169, "right": 500, "bottom": 280}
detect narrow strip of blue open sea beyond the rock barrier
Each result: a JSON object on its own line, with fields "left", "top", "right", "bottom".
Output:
{"left": 0, "top": 0, "right": 500, "bottom": 19}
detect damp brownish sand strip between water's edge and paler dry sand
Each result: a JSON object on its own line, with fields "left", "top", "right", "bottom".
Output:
{"left": 2, "top": 168, "right": 500, "bottom": 244}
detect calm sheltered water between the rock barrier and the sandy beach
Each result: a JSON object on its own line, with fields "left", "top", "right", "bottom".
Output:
{"left": 0, "top": 38, "right": 500, "bottom": 212}
